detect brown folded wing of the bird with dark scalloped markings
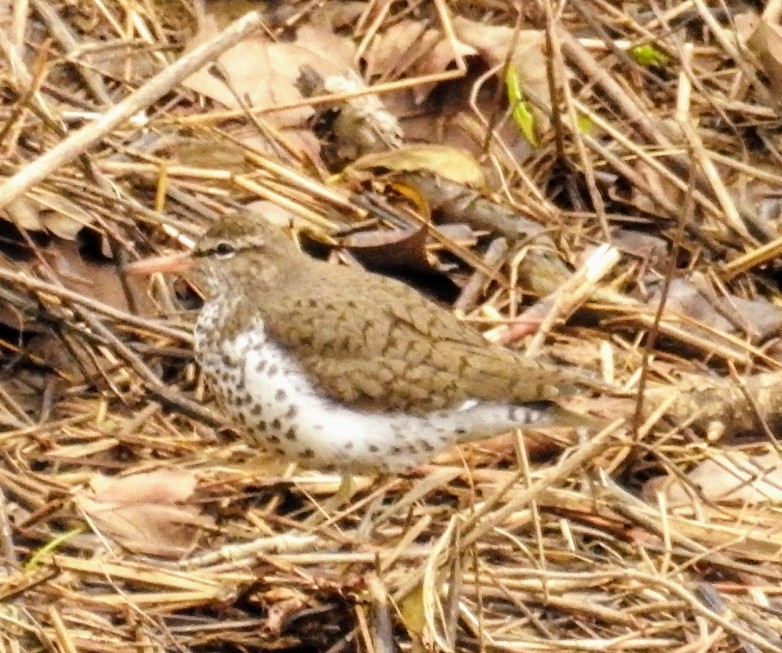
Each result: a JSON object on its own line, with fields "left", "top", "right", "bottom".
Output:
{"left": 263, "top": 267, "right": 588, "bottom": 412}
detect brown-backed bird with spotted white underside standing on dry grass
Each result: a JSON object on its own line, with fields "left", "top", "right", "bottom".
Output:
{"left": 137, "top": 211, "right": 592, "bottom": 479}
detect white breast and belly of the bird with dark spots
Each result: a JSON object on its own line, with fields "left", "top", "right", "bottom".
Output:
{"left": 195, "top": 305, "right": 545, "bottom": 473}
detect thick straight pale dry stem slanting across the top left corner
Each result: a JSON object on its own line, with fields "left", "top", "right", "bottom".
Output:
{"left": 0, "top": 12, "right": 263, "bottom": 207}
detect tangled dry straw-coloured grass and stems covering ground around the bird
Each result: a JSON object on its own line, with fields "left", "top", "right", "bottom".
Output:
{"left": 0, "top": 0, "right": 782, "bottom": 653}
